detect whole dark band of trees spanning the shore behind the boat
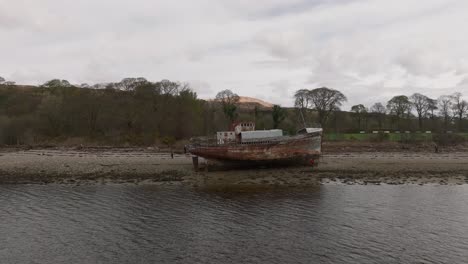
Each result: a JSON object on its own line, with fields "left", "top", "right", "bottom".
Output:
{"left": 0, "top": 77, "right": 468, "bottom": 146}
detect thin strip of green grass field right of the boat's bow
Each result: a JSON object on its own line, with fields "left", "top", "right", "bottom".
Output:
{"left": 324, "top": 132, "right": 468, "bottom": 142}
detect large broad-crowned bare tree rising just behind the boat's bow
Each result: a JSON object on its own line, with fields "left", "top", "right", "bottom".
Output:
{"left": 294, "top": 87, "right": 347, "bottom": 127}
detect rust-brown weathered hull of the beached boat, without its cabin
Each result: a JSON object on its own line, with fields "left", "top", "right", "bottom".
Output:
{"left": 189, "top": 133, "right": 321, "bottom": 164}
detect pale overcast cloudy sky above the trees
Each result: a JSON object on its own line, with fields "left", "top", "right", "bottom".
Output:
{"left": 0, "top": 0, "right": 468, "bottom": 108}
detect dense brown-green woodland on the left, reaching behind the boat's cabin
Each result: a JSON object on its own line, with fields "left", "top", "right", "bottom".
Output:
{"left": 0, "top": 77, "right": 295, "bottom": 145}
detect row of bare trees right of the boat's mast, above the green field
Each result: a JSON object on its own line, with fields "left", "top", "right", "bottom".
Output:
{"left": 294, "top": 87, "right": 468, "bottom": 132}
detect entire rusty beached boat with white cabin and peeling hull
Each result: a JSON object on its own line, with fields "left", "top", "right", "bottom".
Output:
{"left": 186, "top": 122, "right": 322, "bottom": 167}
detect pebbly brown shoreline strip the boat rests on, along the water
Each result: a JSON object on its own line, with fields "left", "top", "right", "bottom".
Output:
{"left": 0, "top": 149, "right": 468, "bottom": 186}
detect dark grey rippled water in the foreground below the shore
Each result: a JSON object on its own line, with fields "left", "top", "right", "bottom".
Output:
{"left": 0, "top": 185, "right": 468, "bottom": 263}
